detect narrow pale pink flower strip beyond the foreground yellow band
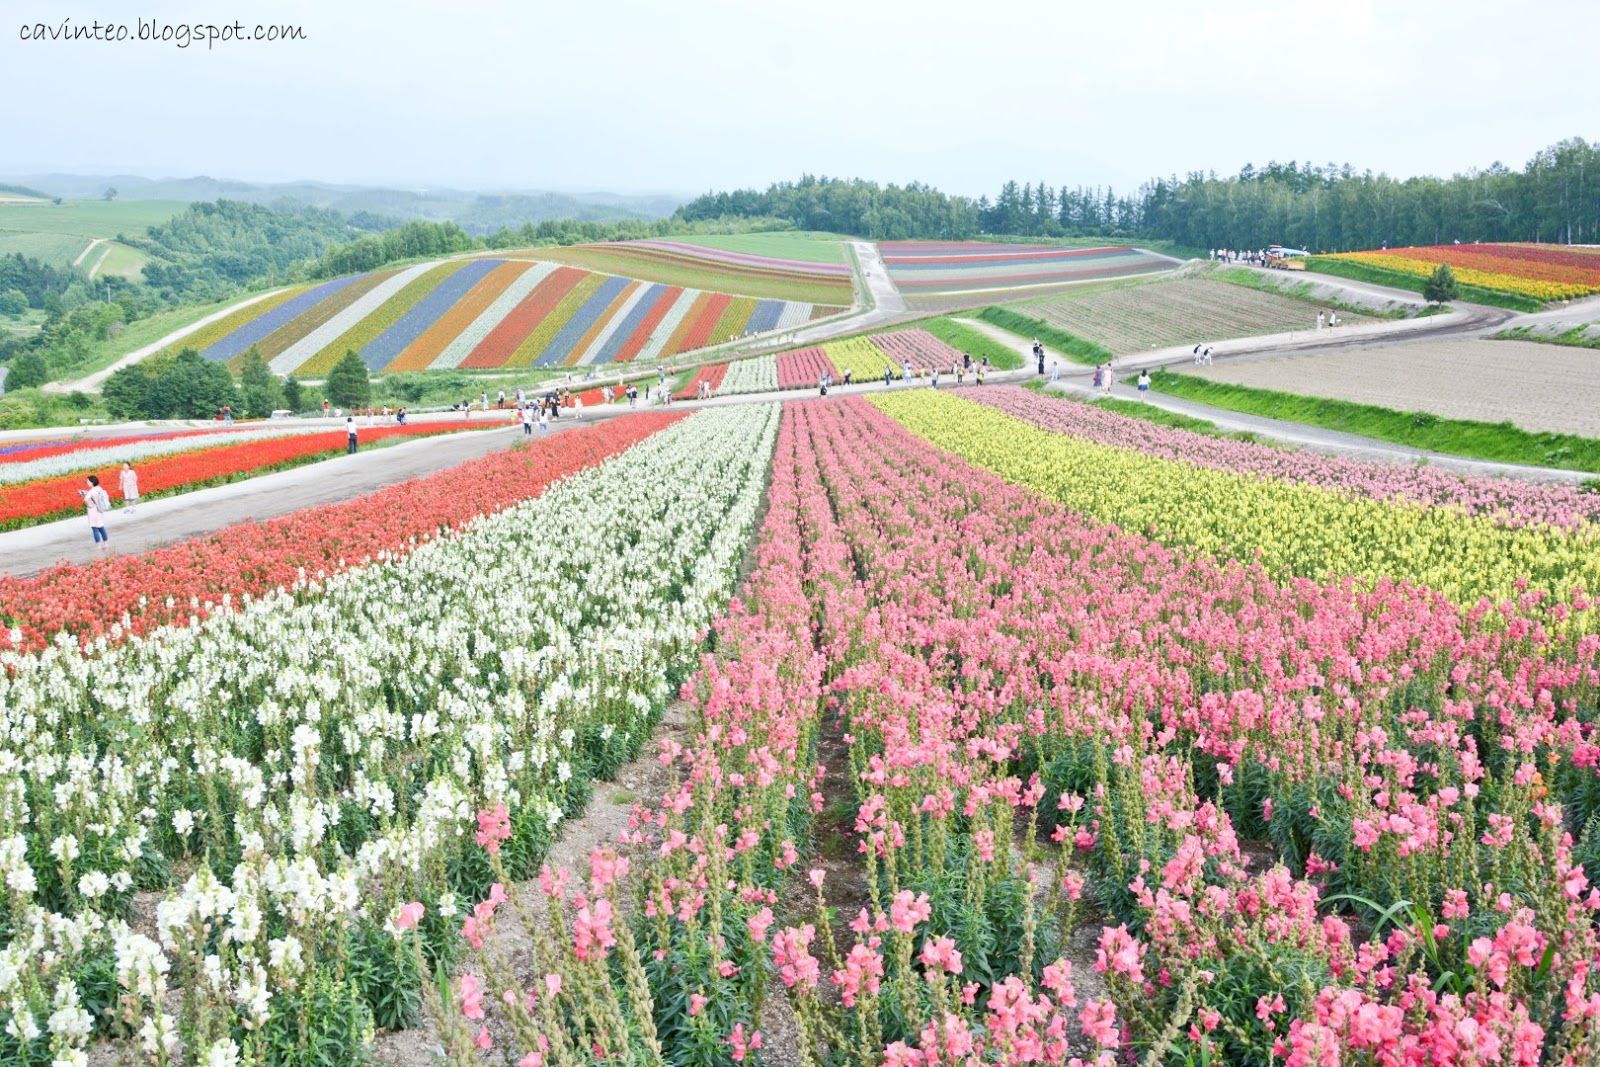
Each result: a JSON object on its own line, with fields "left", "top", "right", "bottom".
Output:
{"left": 971, "top": 387, "right": 1600, "bottom": 530}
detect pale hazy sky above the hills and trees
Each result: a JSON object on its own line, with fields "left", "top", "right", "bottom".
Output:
{"left": 0, "top": 0, "right": 1600, "bottom": 195}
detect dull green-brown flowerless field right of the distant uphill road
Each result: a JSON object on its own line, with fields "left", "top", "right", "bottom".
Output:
{"left": 1018, "top": 277, "right": 1371, "bottom": 355}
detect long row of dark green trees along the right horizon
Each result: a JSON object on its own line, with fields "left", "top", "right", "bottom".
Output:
{"left": 675, "top": 138, "right": 1600, "bottom": 251}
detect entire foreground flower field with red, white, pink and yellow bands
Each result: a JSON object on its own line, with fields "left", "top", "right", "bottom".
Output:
{"left": 18, "top": 379, "right": 1600, "bottom": 1067}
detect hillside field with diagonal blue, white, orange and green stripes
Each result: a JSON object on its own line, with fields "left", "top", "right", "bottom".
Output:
{"left": 179, "top": 258, "right": 848, "bottom": 374}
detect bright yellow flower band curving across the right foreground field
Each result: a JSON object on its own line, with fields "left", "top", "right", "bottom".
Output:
{"left": 872, "top": 390, "right": 1600, "bottom": 629}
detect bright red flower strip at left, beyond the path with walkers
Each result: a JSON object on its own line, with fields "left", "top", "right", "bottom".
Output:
{"left": 0, "top": 422, "right": 488, "bottom": 530}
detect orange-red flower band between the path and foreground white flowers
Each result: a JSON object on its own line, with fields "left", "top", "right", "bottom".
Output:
{"left": 0, "top": 411, "right": 685, "bottom": 648}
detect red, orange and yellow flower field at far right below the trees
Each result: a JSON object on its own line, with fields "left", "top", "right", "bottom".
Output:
{"left": 1323, "top": 245, "right": 1600, "bottom": 301}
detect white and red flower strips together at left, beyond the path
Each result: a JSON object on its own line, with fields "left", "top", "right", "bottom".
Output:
{"left": 0, "top": 419, "right": 494, "bottom": 530}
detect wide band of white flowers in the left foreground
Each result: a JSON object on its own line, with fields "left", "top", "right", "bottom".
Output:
{"left": 0, "top": 405, "right": 778, "bottom": 1054}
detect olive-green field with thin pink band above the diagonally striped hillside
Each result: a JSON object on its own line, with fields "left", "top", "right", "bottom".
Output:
{"left": 502, "top": 240, "right": 854, "bottom": 307}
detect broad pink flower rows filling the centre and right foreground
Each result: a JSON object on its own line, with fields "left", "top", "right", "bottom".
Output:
{"left": 438, "top": 402, "right": 1600, "bottom": 1067}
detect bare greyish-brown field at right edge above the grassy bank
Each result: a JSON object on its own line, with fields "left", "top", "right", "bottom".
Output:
{"left": 1186, "top": 341, "right": 1600, "bottom": 437}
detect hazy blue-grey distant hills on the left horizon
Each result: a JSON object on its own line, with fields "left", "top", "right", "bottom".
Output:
{"left": 6, "top": 174, "right": 688, "bottom": 234}
